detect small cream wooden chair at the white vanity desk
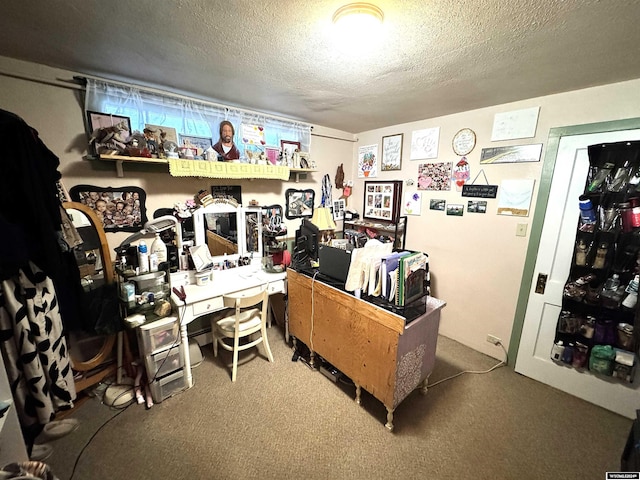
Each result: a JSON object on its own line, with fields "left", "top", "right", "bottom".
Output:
{"left": 211, "top": 288, "right": 273, "bottom": 382}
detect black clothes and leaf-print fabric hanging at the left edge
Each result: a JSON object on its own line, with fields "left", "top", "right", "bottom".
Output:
{"left": 0, "top": 110, "right": 79, "bottom": 449}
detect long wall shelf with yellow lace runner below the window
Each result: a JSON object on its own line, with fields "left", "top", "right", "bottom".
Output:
{"left": 95, "top": 154, "right": 317, "bottom": 183}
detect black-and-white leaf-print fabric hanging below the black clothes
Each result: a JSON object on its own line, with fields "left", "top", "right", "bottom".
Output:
{"left": 0, "top": 262, "right": 76, "bottom": 427}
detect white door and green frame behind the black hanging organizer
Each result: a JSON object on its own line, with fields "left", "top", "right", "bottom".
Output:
{"left": 509, "top": 119, "right": 640, "bottom": 418}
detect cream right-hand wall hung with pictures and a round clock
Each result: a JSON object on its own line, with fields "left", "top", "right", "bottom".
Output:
{"left": 348, "top": 80, "right": 640, "bottom": 358}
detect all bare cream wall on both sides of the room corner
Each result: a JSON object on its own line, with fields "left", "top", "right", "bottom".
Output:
{"left": 5, "top": 53, "right": 640, "bottom": 358}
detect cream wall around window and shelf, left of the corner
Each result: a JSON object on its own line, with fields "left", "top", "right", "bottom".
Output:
{"left": 0, "top": 57, "right": 353, "bottom": 255}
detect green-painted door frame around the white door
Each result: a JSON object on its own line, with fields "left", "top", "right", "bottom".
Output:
{"left": 508, "top": 118, "right": 640, "bottom": 368}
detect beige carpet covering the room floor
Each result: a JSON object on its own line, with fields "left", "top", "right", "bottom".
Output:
{"left": 43, "top": 327, "right": 631, "bottom": 480}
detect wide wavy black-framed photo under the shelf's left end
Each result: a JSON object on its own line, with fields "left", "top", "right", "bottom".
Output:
{"left": 69, "top": 185, "right": 147, "bottom": 232}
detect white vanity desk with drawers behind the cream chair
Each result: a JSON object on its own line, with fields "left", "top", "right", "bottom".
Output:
{"left": 171, "top": 265, "right": 287, "bottom": 388}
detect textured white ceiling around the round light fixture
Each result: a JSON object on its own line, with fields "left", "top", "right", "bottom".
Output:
{"left": 0, "top": 0, "right": 640, "bottom": 133}
